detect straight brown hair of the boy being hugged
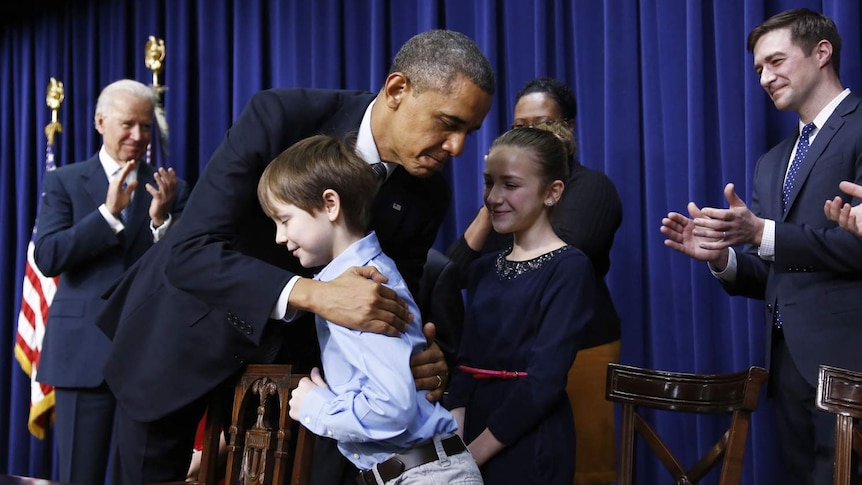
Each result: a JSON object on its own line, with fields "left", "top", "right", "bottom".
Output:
{"left": 257, "top": 135, "right": 377, "bottom": 234}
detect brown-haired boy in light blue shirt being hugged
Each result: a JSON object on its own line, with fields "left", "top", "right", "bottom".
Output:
{"left": 258, "top": 135, "right": 482, "bottom": 484}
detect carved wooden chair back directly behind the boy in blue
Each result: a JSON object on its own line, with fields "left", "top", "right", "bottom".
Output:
{"left": 197, "top": 364, "right": 314, "bottom": 485}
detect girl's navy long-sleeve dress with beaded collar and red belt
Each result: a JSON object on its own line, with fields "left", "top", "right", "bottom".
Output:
{"left": 446, "top": 246, "right": 596, "bottom": 485}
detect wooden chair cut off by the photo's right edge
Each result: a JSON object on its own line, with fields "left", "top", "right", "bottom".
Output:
{"left": 817, "top": 365, "right": 862, "bottom": 485}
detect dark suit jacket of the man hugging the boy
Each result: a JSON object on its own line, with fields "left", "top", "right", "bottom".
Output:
{"left": 99, "top": 89, "right": 449, "bottom": 421}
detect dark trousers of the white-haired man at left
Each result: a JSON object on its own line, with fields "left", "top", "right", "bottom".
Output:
{"left": 54, "top": 385, "right": 117, "bottom": 485}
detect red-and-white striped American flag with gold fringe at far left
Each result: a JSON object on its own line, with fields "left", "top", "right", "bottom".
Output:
{"left": 15, "top": 142, "right": 58, "bottom": 439}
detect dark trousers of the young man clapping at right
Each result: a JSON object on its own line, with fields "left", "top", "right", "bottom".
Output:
{"left": 770, "top": 330, "right": 852, "bottom": 485}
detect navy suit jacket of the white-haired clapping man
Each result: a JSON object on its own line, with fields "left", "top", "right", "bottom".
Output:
{"left": 34, "top": 155, "right": 189, "bottom": 387}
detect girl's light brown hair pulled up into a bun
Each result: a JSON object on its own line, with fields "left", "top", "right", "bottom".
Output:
{"left": 491, "top": 125, "right": 573, "bottom": 185}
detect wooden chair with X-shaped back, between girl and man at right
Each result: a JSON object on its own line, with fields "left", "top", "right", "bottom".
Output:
{"left": 607, "top": 363, "right": 768, "bottom": 485}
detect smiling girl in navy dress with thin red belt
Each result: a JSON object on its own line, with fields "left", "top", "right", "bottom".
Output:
{"left": 446, "top": 123, "right": 595, "bottom": 485}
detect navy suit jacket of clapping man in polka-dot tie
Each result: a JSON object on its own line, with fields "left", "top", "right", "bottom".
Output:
{"left": 724, "top": 93, "right": 862, "bottom": 387}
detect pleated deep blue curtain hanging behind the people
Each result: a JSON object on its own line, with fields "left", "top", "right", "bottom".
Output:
{"left": 0, "top": 0, "right": 862, "bottom": 484}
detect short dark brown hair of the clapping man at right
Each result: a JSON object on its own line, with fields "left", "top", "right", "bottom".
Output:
{"left": 748, "top": 8, "right": 841, "bottom": 77}
